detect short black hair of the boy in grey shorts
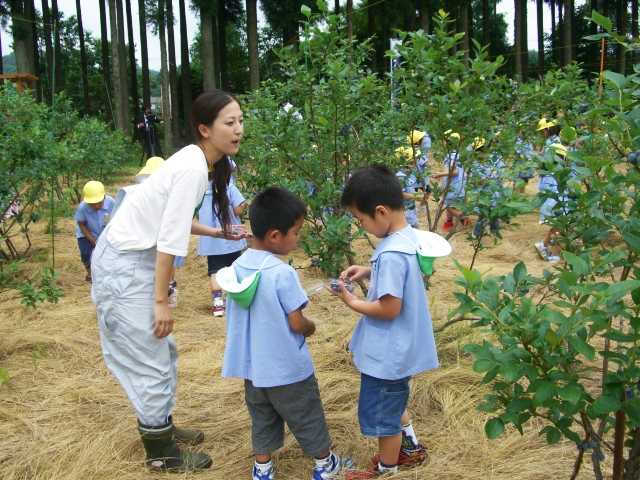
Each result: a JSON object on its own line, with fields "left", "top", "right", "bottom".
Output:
{"left": 249, "top": 187, "right": 307, "bottom": 239}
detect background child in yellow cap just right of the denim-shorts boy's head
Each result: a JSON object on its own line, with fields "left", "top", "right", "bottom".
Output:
{"left": 431, "top": 130, "right": 469, "bottom": 232}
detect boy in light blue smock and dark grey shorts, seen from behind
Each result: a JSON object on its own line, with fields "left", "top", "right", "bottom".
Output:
{"left": 222, "top": 187, "right": 351, "bottom": 480}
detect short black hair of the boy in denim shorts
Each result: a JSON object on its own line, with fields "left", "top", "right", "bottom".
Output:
{"left": 341, "top": 165, "right": 403, "bottom": 217}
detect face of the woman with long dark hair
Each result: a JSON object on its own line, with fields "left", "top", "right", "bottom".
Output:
{"left": 199, "top": 101, "right": 244, "bottom": 161}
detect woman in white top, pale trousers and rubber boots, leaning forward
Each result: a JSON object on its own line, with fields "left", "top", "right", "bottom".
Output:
{"left": 92, "top": 90, "right": 244, "bottom": 472}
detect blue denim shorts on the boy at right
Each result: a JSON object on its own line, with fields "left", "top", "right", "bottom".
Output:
{"left": 358, "top": 373, "right": 411, "bottom": 437}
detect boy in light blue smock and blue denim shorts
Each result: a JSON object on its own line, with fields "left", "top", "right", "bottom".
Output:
{"left": 330, "top": 166, "right": 438, "bottom": 479}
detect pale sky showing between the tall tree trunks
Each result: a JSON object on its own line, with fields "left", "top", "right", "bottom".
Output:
{"left": 1, "top": 0, "right": 586, "bottom": 70}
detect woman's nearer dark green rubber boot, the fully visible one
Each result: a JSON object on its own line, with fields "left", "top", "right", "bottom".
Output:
{"left": 138, "top": 423, "right": 213, "bottom": 473}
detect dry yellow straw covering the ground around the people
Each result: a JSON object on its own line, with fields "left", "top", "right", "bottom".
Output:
{"left": 0, "top": 179, "right": 604, "bottom": 480}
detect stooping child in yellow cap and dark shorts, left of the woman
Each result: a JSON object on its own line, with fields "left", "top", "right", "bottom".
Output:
{"left": 74, "top": 180, "right": 114, "bottom": 282}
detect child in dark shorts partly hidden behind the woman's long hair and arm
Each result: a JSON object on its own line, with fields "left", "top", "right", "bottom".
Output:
{"left": 198, "top": 177, "right": 247, "bottom": 317}
